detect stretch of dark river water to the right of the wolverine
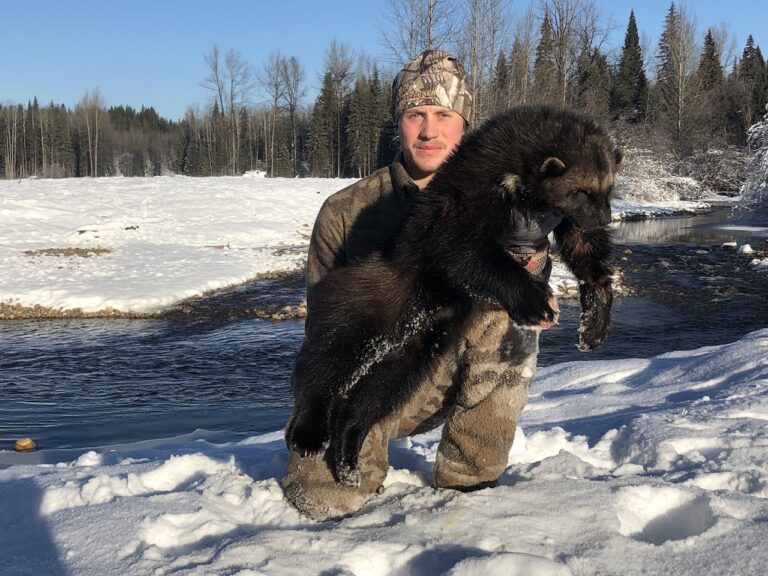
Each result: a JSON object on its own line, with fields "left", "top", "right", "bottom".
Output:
{"left": 539, "top": 209, "right": 768, "bottom": 366}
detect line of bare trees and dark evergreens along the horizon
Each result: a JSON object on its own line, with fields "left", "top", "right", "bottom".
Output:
{"left": 0, "top": 0, "right": 768, "bottom": 178}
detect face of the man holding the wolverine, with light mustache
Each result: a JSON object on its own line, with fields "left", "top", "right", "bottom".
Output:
{"left": 398, "top": 105, "right": 464, "bottom": 187}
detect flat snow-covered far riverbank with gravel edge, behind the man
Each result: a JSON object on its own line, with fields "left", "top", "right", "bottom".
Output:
{"left": 0, "top": 176, "right": 706, "bottom": 320}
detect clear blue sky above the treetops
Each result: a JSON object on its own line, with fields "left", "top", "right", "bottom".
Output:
{"left": 0, "top": 0, "right": 768, "bottom": 119}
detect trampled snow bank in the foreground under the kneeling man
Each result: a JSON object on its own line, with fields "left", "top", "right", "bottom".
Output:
{"left": 0, "top": 330, "right": 768, "bottom": 576}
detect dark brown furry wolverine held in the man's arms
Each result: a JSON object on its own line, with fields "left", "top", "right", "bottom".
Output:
{"left": 286, "top": 106, "right": 622, "bottom": 485}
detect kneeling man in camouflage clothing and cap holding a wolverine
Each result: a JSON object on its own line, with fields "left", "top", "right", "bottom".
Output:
{"left": 283, "top": 50, "right": 549, "bottom": 520}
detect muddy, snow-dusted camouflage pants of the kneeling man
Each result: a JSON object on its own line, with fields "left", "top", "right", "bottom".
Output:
{"left": 283, "top": 309, "right": 538, "bottom": 520}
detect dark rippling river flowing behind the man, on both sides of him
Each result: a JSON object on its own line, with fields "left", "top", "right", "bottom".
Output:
{"left": 0, "top": 212, "right": 768, "bottom": 449}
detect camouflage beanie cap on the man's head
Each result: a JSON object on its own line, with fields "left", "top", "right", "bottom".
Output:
{"left": 392, "top": 50, "right": 472, "bottom": 122}
